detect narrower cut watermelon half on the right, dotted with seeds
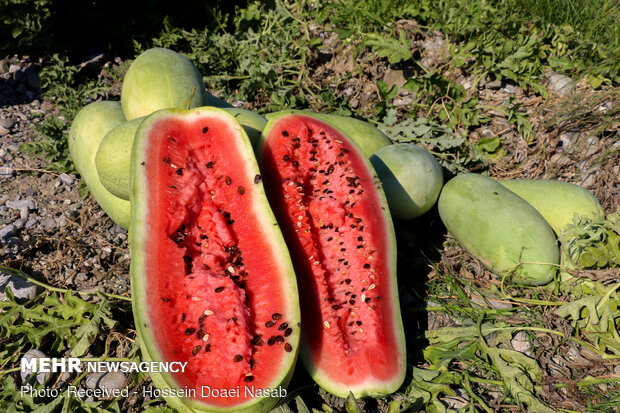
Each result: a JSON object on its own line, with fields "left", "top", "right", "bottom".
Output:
{"left": 258, "top": 112, "right": 406, "bottom": 397}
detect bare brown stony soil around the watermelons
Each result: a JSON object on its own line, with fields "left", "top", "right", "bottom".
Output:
{"left": 0, "top": 21, "right": 620, "bottom": 411}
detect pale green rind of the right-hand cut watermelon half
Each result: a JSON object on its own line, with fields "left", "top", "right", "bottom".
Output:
{"left": 257, "top": 110, "right": 407, "bottom": 398}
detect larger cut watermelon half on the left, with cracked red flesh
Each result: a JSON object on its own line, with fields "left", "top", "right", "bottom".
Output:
{"left": 130, "top": 107, "right": 300, "bottom": 412}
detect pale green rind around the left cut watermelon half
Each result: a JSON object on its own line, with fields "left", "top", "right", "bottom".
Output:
{"left": 130, "top": 107, "right": 301, "bottom": 412}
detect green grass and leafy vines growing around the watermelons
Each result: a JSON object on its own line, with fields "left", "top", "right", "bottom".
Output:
{"left": 0, "top": 0, "right": 620, "bottom": 413}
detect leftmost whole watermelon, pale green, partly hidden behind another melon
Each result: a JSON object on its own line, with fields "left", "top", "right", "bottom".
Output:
{"left": 69, "top": 101, "right": 131, "bottom": 229}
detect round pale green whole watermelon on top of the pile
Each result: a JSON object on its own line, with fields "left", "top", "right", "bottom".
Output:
{"left": 121, "top": 48, "right": 209, "bottom": 120}
